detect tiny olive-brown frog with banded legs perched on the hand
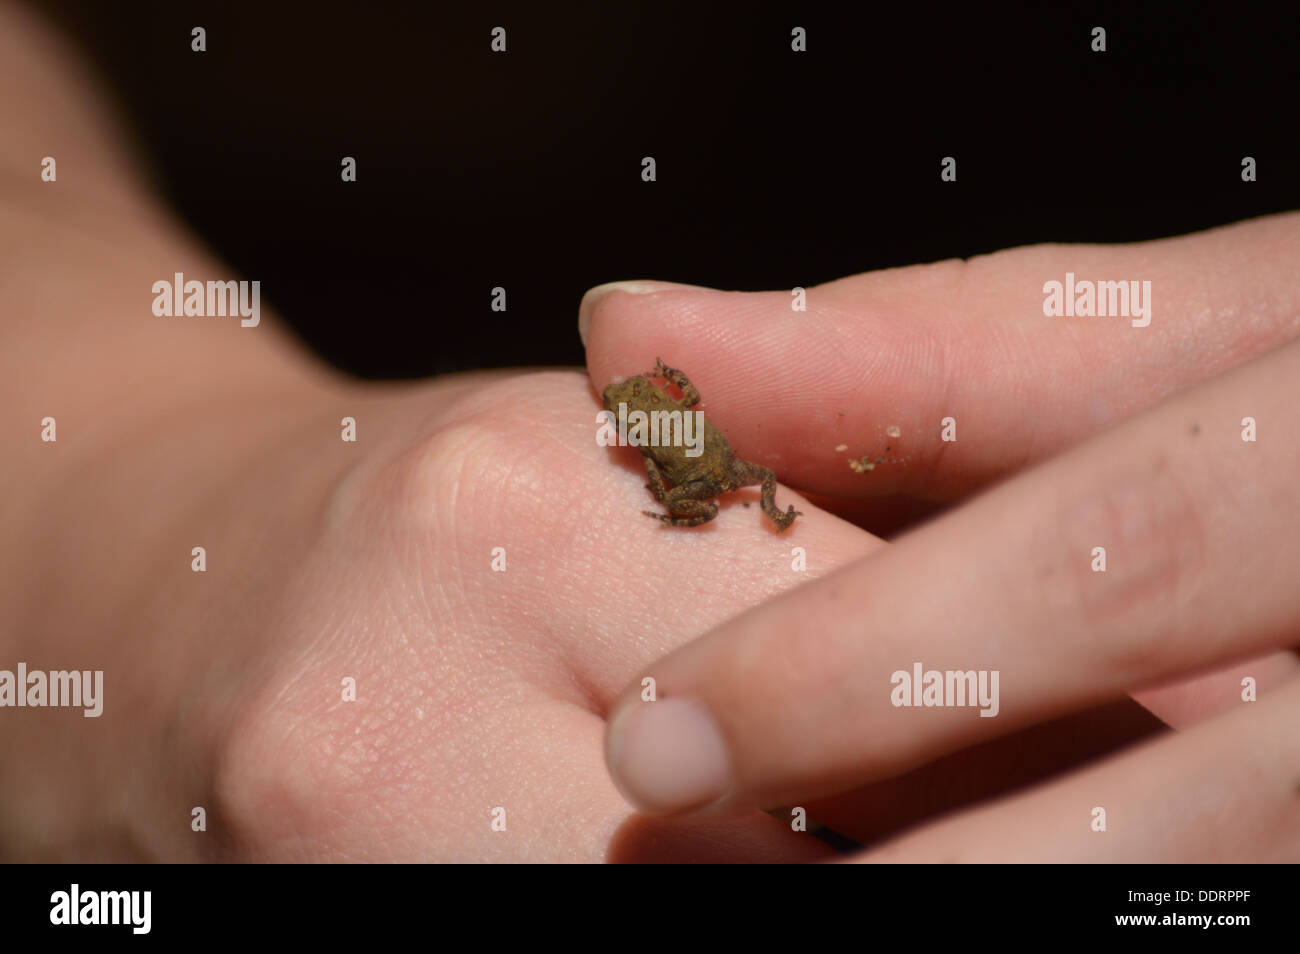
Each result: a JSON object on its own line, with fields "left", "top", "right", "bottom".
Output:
{"left": 603, "top": 359, "right": 803, "bottom": 530}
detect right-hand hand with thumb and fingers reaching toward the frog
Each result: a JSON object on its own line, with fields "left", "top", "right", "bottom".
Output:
{"left": 584, "top": 216, "right": 1300, "bottom": 860}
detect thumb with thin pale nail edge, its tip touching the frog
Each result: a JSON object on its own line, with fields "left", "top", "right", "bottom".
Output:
{"left": 580, "top": 213, "right": 1300, "bottom": 499}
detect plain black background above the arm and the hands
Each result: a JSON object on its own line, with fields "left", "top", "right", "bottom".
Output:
{"left": 43, "top": 0, "right": 1300, "bottom": 377}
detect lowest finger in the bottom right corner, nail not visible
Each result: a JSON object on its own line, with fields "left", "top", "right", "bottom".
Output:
{"left": 855, "top": 681, "right": 1300, "bottom": 864}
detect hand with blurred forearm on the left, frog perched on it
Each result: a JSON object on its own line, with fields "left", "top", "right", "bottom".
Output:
{"left": 0, "top": 4, "right": 852, "bottom": 862}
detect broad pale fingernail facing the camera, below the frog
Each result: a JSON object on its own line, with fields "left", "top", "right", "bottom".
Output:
{"left": 607, "top": 699, "right": 731, "bottom": 812}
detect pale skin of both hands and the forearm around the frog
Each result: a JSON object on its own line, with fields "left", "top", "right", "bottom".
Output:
{"left": 0, "top": 1, "right": 1300, "bottom": 860}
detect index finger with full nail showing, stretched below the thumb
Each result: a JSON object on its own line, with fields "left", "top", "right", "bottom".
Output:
{"left": 607, "top": 335, "right": 1300, "bottom": 811}
